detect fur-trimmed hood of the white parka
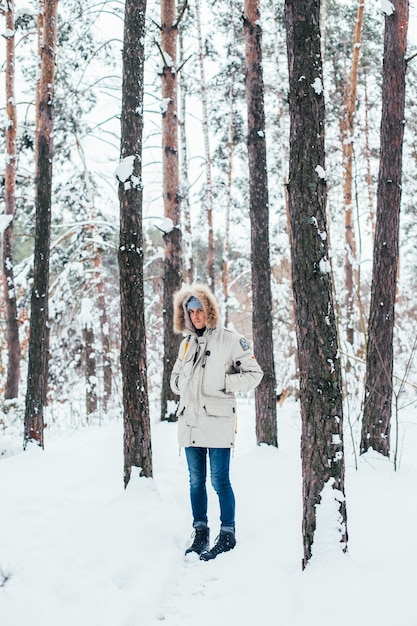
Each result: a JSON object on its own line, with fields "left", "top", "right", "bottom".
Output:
{"left": 174, "top": 283, "right": 220, "bottom": 334}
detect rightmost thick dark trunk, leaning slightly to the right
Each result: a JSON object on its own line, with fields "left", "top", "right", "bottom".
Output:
{"left": 361, "top": 0, "right": 409, "bottom": 456}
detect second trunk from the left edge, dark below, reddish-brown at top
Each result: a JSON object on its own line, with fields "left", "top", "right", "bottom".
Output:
{"left": 24, "top": 0, "right": 58, "bottom": 447}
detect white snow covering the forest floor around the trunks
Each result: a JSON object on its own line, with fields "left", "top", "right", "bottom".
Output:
{"left": 0, "top": 400, "right": 417, "bottom": 626}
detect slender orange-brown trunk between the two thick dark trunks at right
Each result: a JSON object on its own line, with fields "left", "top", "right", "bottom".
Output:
{"left": 340, "top": 0, "right": 365, "bottom": 346}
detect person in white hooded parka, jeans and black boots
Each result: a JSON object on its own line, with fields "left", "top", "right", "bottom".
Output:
{"left": 171, "top": 284, "right": 263, "bottom": 561}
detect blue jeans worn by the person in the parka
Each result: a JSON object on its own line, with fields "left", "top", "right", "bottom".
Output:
{"left": 185, "top": 447, "right": 235, "bottom": 531}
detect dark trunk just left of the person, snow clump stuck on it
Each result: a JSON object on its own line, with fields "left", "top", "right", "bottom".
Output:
{"left": 118, "top": 0, "right": 152, "bottom": 487}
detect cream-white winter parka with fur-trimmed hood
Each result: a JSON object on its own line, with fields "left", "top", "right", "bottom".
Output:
{"left": 171, "top": 285, "right": 263, "bottom": 448}
